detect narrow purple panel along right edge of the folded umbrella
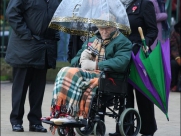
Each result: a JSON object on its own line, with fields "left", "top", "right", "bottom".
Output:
{"left": 161, "top": 39, "right": 171, "bottom": 105}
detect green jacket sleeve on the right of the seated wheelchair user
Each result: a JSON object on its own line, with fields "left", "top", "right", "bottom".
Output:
{"left": 98, "top": 35, "right": 132, "bottom": 73}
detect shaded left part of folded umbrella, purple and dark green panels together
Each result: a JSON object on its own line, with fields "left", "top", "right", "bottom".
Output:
{"left": 128, "top": 52, "right": 164, "bottom": 110}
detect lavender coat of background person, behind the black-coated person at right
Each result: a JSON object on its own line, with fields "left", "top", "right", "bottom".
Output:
{"left": 150, "top": 0, "right": 167, "bottom": 50}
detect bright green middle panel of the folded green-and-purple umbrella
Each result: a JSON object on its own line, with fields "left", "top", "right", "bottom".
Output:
{"left": 139, "top": 42, "right": 168, "bottom": 118}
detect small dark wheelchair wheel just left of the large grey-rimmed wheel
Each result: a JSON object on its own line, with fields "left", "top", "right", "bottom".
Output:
{"left": 94, "top": 120, "right": 106, "bottom": 136}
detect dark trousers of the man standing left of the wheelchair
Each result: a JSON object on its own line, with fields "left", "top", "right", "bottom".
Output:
{"left": 10, "top": 67, "right": 47, "bottom": 125}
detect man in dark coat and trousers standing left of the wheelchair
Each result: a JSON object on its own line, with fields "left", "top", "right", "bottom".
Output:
{"left": 5, "top": 0, "right": 59, "bottom": 132}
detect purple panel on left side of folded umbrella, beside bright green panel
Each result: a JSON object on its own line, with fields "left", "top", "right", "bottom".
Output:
{"left": 132, "top": 50, "right": 165, "bottom": 111}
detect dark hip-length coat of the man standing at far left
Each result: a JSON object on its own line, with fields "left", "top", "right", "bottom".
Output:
{"left": 5, "top": 0, "right": 59, "bottom": 68}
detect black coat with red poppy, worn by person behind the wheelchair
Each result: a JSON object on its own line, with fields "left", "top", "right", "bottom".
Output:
{"left": 126, "top": 0, "right": 158, "bottom": 52}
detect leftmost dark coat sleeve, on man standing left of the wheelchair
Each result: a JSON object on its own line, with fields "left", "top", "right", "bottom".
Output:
{"left": 6, "top": 0, "right": 32, "bottom": 40}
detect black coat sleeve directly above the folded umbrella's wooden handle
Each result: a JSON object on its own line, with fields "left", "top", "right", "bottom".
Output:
{"left": 142, "top": 0, "right": 158, "bottom": 46}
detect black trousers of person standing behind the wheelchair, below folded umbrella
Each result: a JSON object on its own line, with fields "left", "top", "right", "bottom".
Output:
{"left": 127, "top": 84, "right": 157, "bottom": 135}
